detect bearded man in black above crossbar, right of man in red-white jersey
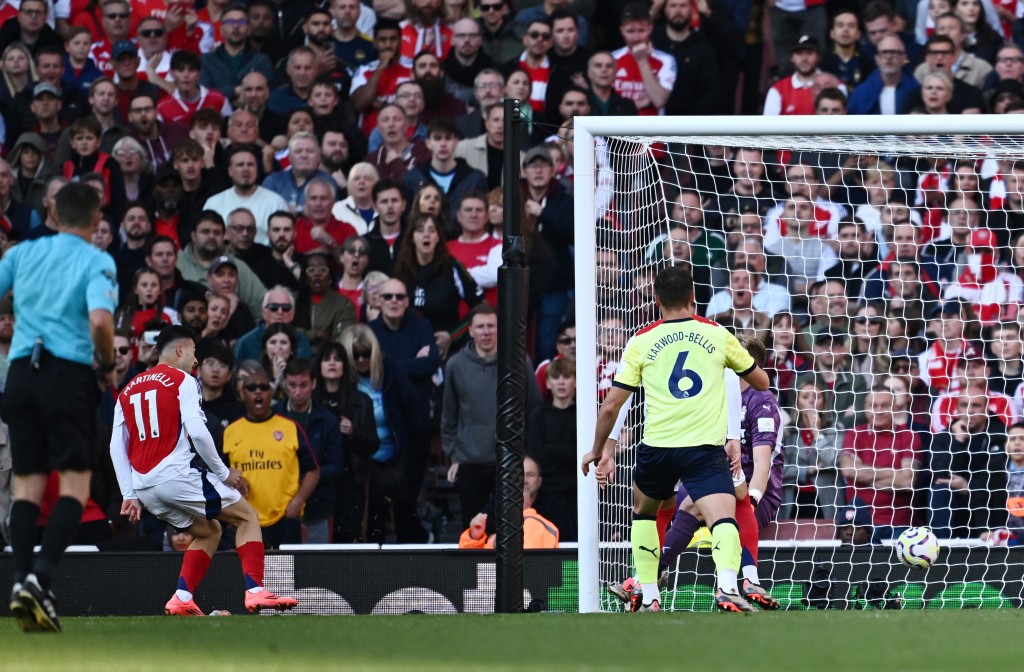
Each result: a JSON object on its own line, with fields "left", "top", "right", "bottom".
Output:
{"left": 652, "top": 0, "right": 722, "bottom": 115}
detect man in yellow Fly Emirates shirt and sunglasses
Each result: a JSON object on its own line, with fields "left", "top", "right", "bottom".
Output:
{"left": 223, "top": 370, "right": 319, "bottom": 548}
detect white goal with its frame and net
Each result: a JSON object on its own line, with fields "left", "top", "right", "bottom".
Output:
{"left": 574, "top": 116, "right": 1024, "bottom": 612}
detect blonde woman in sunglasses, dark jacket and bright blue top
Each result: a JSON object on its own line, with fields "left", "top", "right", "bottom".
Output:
{"left": 338, "top": 325, "right": 428, "bottom": 544}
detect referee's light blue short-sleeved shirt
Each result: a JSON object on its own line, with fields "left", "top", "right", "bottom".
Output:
{"left": 0, "top": 234, "right": 118, "bottom": 366}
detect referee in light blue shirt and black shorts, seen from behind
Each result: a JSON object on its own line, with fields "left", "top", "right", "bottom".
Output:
{"left": 0, "top": 183, "right": 118, "bottom": 632}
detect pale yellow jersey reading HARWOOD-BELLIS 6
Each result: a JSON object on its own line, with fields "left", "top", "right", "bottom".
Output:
{"left": 612, "top": 317, "right": 757, "bottom": 448}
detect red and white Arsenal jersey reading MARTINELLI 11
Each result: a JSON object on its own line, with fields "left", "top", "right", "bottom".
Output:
{"left": 114, "top": 364, "right": 206, "bottom": 490}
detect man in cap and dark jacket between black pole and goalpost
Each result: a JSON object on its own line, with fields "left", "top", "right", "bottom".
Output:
{"left": 522, "top": 142, "right": 575, "bottom": 361}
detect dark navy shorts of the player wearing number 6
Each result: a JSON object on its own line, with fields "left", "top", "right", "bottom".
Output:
{"left": 633, "top": 444, "right": 736, "bottom": 502}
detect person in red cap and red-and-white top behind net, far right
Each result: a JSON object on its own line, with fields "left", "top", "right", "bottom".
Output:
{"left": 942, "top": 228, "right": 1024, "bottom": 327}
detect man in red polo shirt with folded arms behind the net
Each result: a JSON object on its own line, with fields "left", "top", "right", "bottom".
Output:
{"left": 839, "top": 387, "right": 922, "bottom": 543}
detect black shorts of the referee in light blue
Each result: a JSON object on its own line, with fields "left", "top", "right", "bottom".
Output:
{"left": 3, "top": 352, "right": 100, "bottom": 476}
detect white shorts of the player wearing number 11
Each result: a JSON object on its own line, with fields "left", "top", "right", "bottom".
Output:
{"left": 135, "top": 468, "right": 242, "bottom": 530}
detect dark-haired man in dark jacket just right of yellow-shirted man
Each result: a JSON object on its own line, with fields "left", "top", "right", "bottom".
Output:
{"left": 274, "top": 360, "right": 345, "bottom": 544}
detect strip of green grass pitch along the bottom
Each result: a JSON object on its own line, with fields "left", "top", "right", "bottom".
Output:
{"left": 0, "top": 610, "right": 1024, "bottom": 672}
